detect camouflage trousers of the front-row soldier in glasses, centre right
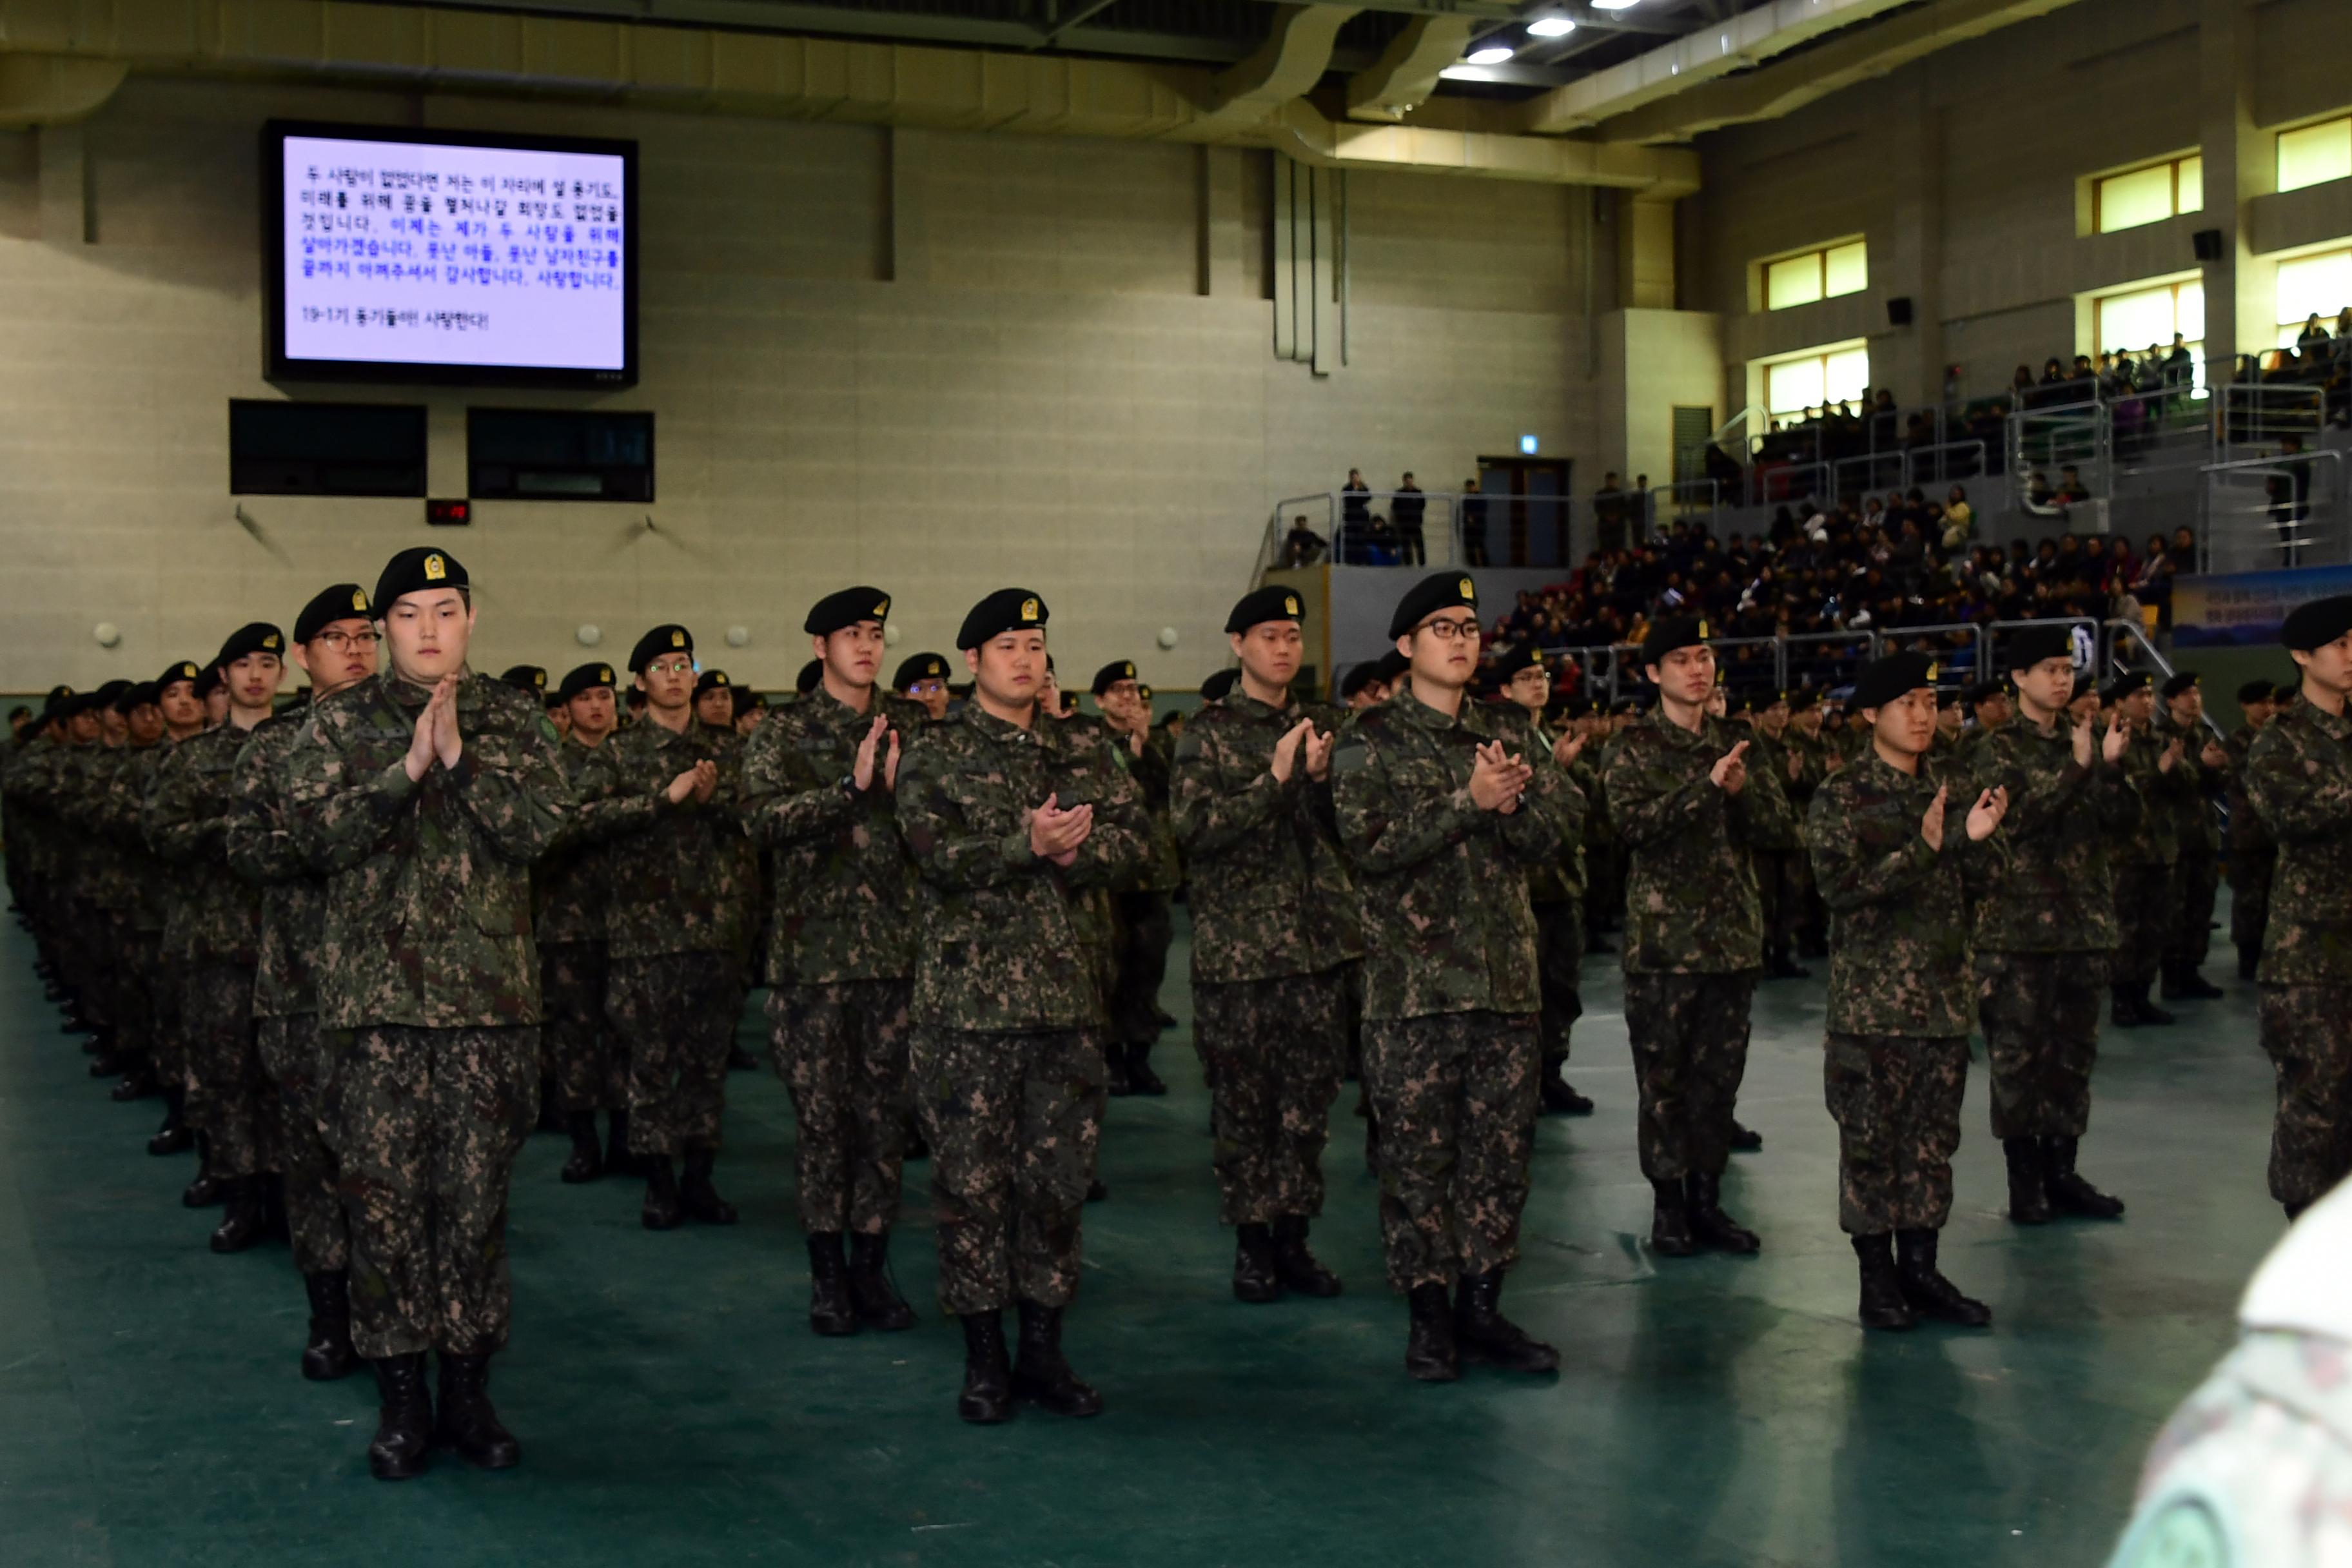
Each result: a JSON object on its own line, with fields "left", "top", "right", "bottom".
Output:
{"left": 1364, "top": 1014, "right": 1543, "bottom": 1293}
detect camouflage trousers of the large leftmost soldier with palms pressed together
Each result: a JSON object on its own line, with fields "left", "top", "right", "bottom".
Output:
{"left": 320, "top": 1025, "right": 538, "bottom": 1361}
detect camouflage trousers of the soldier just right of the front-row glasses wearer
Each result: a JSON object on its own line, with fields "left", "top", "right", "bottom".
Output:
{"left": 1625, "top": 968, "right": 1757, "bottom": 1182}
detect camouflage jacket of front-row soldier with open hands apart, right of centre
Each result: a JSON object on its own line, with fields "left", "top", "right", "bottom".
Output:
{"left": 1807, "top": 754, "right": 2006, "bottom": 1037}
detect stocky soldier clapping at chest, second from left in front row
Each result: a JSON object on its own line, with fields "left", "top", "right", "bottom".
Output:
{"left": 896, "top": 588, "right": 1150, "bottom": 1422}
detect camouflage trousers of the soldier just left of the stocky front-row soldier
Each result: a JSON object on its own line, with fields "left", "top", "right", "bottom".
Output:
{"left": 767, "top": 980, "right": 915, "bottom": 1237}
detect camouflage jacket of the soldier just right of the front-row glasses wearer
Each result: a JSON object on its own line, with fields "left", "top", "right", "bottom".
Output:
{"left": 1604, "top": 712, "right": 1790, "bottom": 975}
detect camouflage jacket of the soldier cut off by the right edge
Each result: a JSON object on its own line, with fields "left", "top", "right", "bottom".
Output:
{"left": 2246, "top": 703, "right": 2352, "bottom": 985}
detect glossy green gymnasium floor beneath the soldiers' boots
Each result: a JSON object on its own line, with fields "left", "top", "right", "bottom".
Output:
{"left": 0, "top": 907, "right": 2282, "bottom": 1568}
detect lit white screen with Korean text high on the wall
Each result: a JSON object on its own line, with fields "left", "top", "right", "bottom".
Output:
{"left": 277, "top": 134, "right": 628, "bottom": 371}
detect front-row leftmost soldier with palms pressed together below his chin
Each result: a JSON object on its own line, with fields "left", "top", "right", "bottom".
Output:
{"left": 287, "top": 550, "right": 571, "bottom": 1481}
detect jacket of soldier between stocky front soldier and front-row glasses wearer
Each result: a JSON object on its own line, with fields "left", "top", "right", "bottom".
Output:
{"left": 1173, "top": 691, "right": 1364, "bottom": 985}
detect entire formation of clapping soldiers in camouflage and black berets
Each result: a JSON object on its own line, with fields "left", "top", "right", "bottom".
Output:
{"left": 5, "top": 550, "right": 2352, "bottom": 1478}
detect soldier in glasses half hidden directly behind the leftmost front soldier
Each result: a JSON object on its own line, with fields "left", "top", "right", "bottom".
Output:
{"left": 224, "top": 583, "right": 377, "bottom": 1380}
